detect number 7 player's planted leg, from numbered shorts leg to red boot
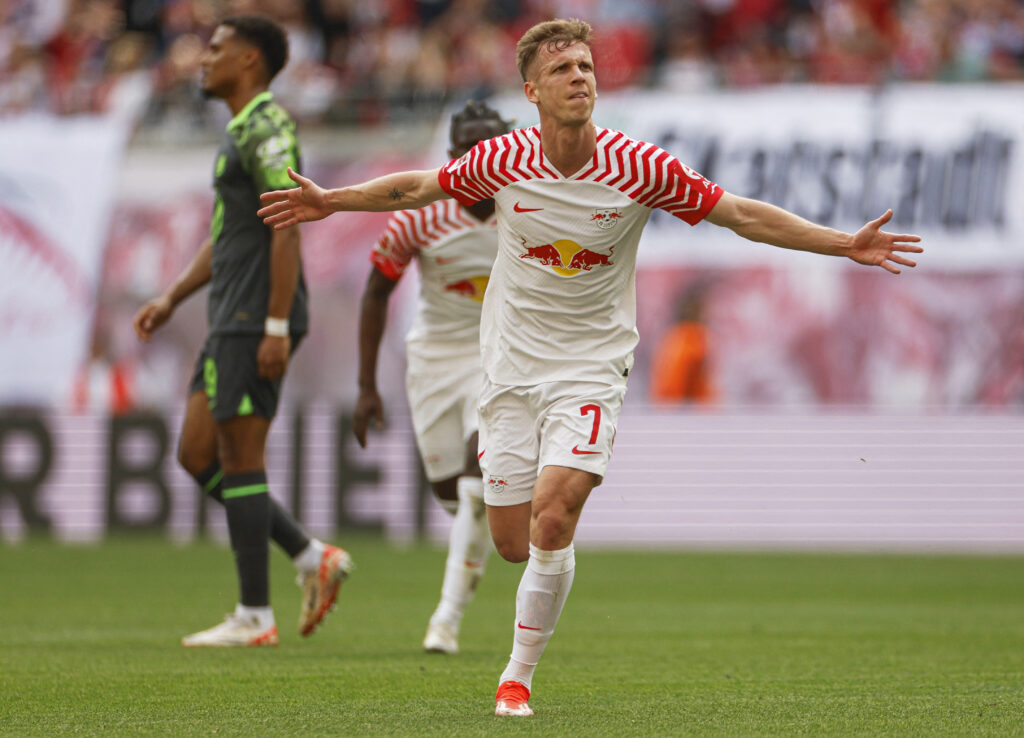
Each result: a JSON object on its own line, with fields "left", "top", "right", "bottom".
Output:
{"left": 495, "top": 383, "right": 625, "bottom": 715}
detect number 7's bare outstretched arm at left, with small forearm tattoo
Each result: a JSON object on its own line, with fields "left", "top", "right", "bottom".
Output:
{"left": 257, "top": 168, "right": 451, "bottom": 229}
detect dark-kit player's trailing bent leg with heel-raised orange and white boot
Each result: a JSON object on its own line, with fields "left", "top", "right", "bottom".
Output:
{"left": 178, "top": 341, "right": 351, "bottom": 636}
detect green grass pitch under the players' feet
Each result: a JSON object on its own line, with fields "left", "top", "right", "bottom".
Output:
{"left": 0, "top": 538, "right": 1024, "bottom": 736}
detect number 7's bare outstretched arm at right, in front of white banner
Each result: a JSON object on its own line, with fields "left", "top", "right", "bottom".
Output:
{"left": 707, "top": 192, "right": 924, "bottom": 274}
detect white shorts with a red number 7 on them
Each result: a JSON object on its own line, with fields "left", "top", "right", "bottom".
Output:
{"left": 479, "top": 379, "right": 626, "bottom": 506}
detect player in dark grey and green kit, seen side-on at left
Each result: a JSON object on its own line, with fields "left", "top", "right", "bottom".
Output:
{"left": 134, "top": 15, "right": 352, "bottom": 647}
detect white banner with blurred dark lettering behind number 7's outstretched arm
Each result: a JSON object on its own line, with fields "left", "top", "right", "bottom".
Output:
{"left": 483, "top": 85, "right": 1024, "bottom": 270}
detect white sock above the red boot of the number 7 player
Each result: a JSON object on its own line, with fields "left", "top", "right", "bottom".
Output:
{"left": 499, "top": 544, "right": 575, "bottom": 689}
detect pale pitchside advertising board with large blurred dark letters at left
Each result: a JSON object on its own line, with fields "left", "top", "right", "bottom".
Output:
{"left": 0, "top": 403, "right": 1024, "bottom": 553}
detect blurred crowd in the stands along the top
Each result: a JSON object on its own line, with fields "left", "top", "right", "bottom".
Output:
{"left": 0, "top": 0, "right": 1024, "bottom": 131}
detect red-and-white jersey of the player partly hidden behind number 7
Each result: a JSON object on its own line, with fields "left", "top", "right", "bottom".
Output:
{"left": 371, "top": 200, "right": 498, "bottom": 365}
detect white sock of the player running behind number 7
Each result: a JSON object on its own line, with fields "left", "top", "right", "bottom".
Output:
{"left": 430, "top": 477, "right": 492, "bottom": 633}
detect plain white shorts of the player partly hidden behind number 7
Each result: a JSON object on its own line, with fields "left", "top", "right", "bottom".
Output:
{"left": 406, "top": 353, "right": 483, "bottom": 482}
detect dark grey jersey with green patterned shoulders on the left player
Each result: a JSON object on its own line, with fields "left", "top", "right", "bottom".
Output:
{"left": 207, "top": 92, "right": 308, "bottom": 335}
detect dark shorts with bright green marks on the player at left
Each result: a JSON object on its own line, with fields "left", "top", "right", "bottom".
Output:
{"left": 188, "top": 335, "right": 302, "bottom": 422}
